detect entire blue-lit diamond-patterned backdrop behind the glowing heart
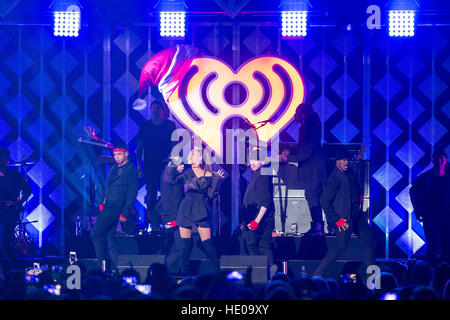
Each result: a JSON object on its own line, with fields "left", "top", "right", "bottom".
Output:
{"left": 0, "top": 22, "right": 450, "bottom": 258}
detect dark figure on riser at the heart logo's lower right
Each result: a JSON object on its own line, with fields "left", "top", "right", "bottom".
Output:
{"left": 280, "top": 103, "right": 326, "bottom": 236}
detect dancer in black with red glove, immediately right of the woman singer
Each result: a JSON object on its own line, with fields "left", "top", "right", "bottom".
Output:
{"left": 242, "top": 160, "right": 275, "bottom": 267}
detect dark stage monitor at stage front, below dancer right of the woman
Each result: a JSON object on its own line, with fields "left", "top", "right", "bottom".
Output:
{"left": 220, "top": 255, "right": 269, "bottom": 284}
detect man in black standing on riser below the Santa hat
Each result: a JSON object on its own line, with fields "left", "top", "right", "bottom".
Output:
{"left": 136, "top": 100, "right": 175, "bottom": 232}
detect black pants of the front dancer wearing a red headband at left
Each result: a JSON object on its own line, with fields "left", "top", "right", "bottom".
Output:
{"left": 91, "top": 208, "right": 122, "bottom": 269}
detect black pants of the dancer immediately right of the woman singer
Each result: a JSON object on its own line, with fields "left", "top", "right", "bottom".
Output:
{"left": 243, "top": 218, "right": 274, "bottom": 266}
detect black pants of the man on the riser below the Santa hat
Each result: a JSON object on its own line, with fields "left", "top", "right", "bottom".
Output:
{"left": 143, "top": 165, "right": 164, "bottom": 230}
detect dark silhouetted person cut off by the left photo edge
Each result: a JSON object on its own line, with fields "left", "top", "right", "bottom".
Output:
{"left": 0, "top": 147, "right": 31, "bottom": 268}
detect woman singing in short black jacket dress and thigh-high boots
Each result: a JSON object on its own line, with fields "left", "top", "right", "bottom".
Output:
{"left": 168, "top": 149, "right": 223, "bottom": 273}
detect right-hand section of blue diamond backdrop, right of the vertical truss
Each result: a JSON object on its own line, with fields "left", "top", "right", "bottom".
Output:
{"left": 371, "top": 27, "right": 450, "bottom": 258}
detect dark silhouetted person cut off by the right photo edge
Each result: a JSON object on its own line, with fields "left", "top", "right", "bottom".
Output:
{"left": 409, "top": 149, "right": 450, "bottom": 264}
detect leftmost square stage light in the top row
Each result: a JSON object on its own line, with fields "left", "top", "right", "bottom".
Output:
{"left": 53, "top": 0, "right": 81, "bottom": 37}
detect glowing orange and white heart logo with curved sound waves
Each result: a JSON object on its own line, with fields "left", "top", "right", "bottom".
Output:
{"left": 167, "top": 56, "right": 304, "bottom": 155}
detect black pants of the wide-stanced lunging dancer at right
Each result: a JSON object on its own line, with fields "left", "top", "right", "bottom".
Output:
{"left": 314, "top": 214, "right": 376, "bottom": 276}
